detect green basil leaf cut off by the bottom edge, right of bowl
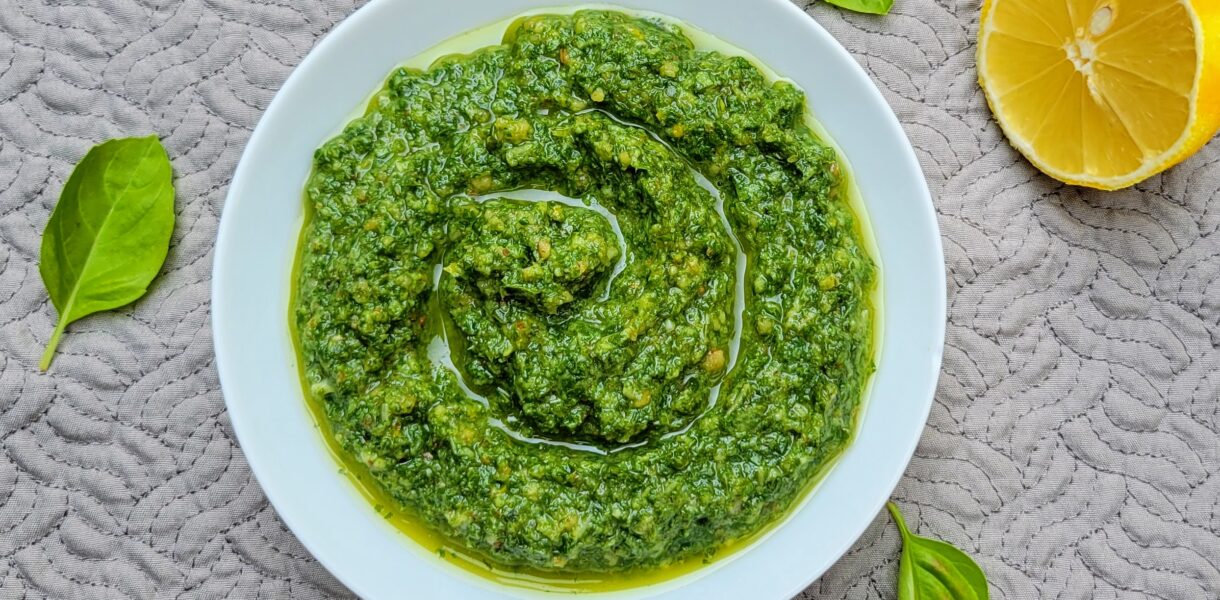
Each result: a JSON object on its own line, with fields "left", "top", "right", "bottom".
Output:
{"left": 886, "top": 502, "right": 988, "bottom": 600}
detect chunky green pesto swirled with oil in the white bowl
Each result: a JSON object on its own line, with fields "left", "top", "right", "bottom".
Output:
{"left": 301, "top": 11, "right": 875, "bottom": 573}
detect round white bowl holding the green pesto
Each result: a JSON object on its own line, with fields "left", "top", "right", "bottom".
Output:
{"left": 212, "top": 0, "right": 946, "bottom": 599}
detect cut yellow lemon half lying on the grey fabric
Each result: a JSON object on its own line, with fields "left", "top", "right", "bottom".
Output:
{"left": 978, "top": 0, "right": 1220, "bottom": 189}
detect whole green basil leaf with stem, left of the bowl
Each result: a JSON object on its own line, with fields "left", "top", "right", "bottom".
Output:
{"left": 38, "top": 135, "right": 173, "bottom": 371}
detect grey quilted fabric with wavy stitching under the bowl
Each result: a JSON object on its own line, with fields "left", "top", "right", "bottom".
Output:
{"left": 0, "top": 0, "right": 1220, "bottom": 599}
